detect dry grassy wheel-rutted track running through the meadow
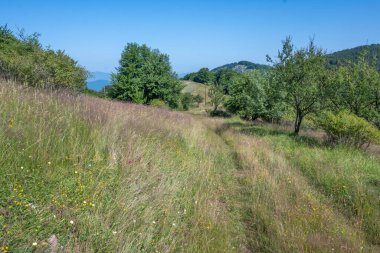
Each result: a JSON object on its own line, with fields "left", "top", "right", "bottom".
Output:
{"left": 206, "top": 118, "right": 379, "bottom": 252}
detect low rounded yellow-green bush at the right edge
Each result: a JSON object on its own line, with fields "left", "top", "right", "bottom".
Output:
{"left": 316, "top": 111, "right": 380, "bottom": 147}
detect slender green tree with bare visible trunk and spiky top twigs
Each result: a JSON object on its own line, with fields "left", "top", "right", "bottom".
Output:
{"left": 268, "top": 37, "right": 327, "bottom": 134}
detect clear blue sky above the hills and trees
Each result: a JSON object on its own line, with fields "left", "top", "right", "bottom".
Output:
{"left": 0, "top": 0, "right": 380, "bottom": 73}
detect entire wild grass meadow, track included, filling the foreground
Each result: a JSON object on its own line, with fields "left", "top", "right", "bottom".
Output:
{"left": 0, "top": 82, "right": 380, "bottom": 252}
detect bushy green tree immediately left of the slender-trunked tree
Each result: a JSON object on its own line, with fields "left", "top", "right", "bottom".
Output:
{"left": 226, "top": 71, "right": 268, "bottom": 120}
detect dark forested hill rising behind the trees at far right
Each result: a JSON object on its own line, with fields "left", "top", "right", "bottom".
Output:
{"left": 327, "top": 44, "right": 380, "bottom": 70}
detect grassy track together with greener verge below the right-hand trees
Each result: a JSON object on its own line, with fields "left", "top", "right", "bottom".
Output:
{"left": 223, "top": 121, "right": 380, "bottom": 252}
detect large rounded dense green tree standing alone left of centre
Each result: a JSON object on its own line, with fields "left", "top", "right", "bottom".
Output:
{"left": 109, "top": 43, "right": 183, "bottom": 108}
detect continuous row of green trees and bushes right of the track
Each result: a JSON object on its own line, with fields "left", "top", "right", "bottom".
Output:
{"left": 190, "top": 38, "right": 380, "bottom": 146}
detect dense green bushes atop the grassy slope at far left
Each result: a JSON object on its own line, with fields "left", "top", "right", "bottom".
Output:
{"left": 0, "top": 26, "right": 88, "bottom": 90}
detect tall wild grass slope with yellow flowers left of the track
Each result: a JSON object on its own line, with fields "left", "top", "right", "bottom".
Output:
{"left": 0, "top": 83, "right": 244, "bottom": 252}
